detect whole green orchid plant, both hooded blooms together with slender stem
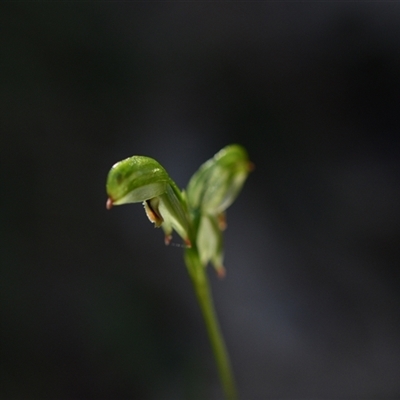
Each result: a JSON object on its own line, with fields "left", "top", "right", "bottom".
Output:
{"left": 106, "top": 144, "right": 253, "bottom": 400}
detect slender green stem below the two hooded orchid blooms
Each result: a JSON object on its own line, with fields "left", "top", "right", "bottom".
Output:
{"left": 185, "top": 247, "right": 238, "bottom": 400}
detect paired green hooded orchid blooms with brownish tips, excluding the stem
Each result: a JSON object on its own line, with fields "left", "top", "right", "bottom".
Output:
{"left": 106, "top": 144, "right": 252, "bottom": 276}
